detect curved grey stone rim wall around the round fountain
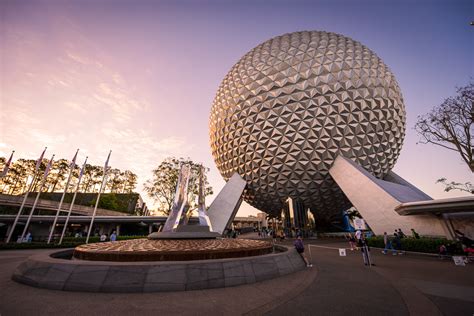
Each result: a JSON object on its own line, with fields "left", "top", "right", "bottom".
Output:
{"left": 12, "top": 246, "right": 305, "bottom": 293}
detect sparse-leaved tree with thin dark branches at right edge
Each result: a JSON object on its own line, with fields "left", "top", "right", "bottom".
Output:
{"left": 415, "top": 82, "right": 474, "bottom": 172}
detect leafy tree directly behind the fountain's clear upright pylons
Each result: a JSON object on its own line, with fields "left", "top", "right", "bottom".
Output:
{"left": 144, "top": 157, "right": 213, "bottom": 215}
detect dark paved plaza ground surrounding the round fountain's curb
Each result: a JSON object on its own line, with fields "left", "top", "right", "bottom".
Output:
{"left": 0, "top": 241, "right": 474, "bottom": 316}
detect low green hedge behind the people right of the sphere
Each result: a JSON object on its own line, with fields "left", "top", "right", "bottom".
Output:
{"left": 368, "top": 236, "right": 462, "bottom": 254}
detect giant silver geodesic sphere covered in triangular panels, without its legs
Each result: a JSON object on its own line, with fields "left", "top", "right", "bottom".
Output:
{"left": 209, "top": 31, "right": 405, "bottom": 221}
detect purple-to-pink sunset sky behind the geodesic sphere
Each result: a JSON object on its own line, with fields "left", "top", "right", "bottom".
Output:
{"left": 0, "top": 0, "right": 474, "bottom": 216}
